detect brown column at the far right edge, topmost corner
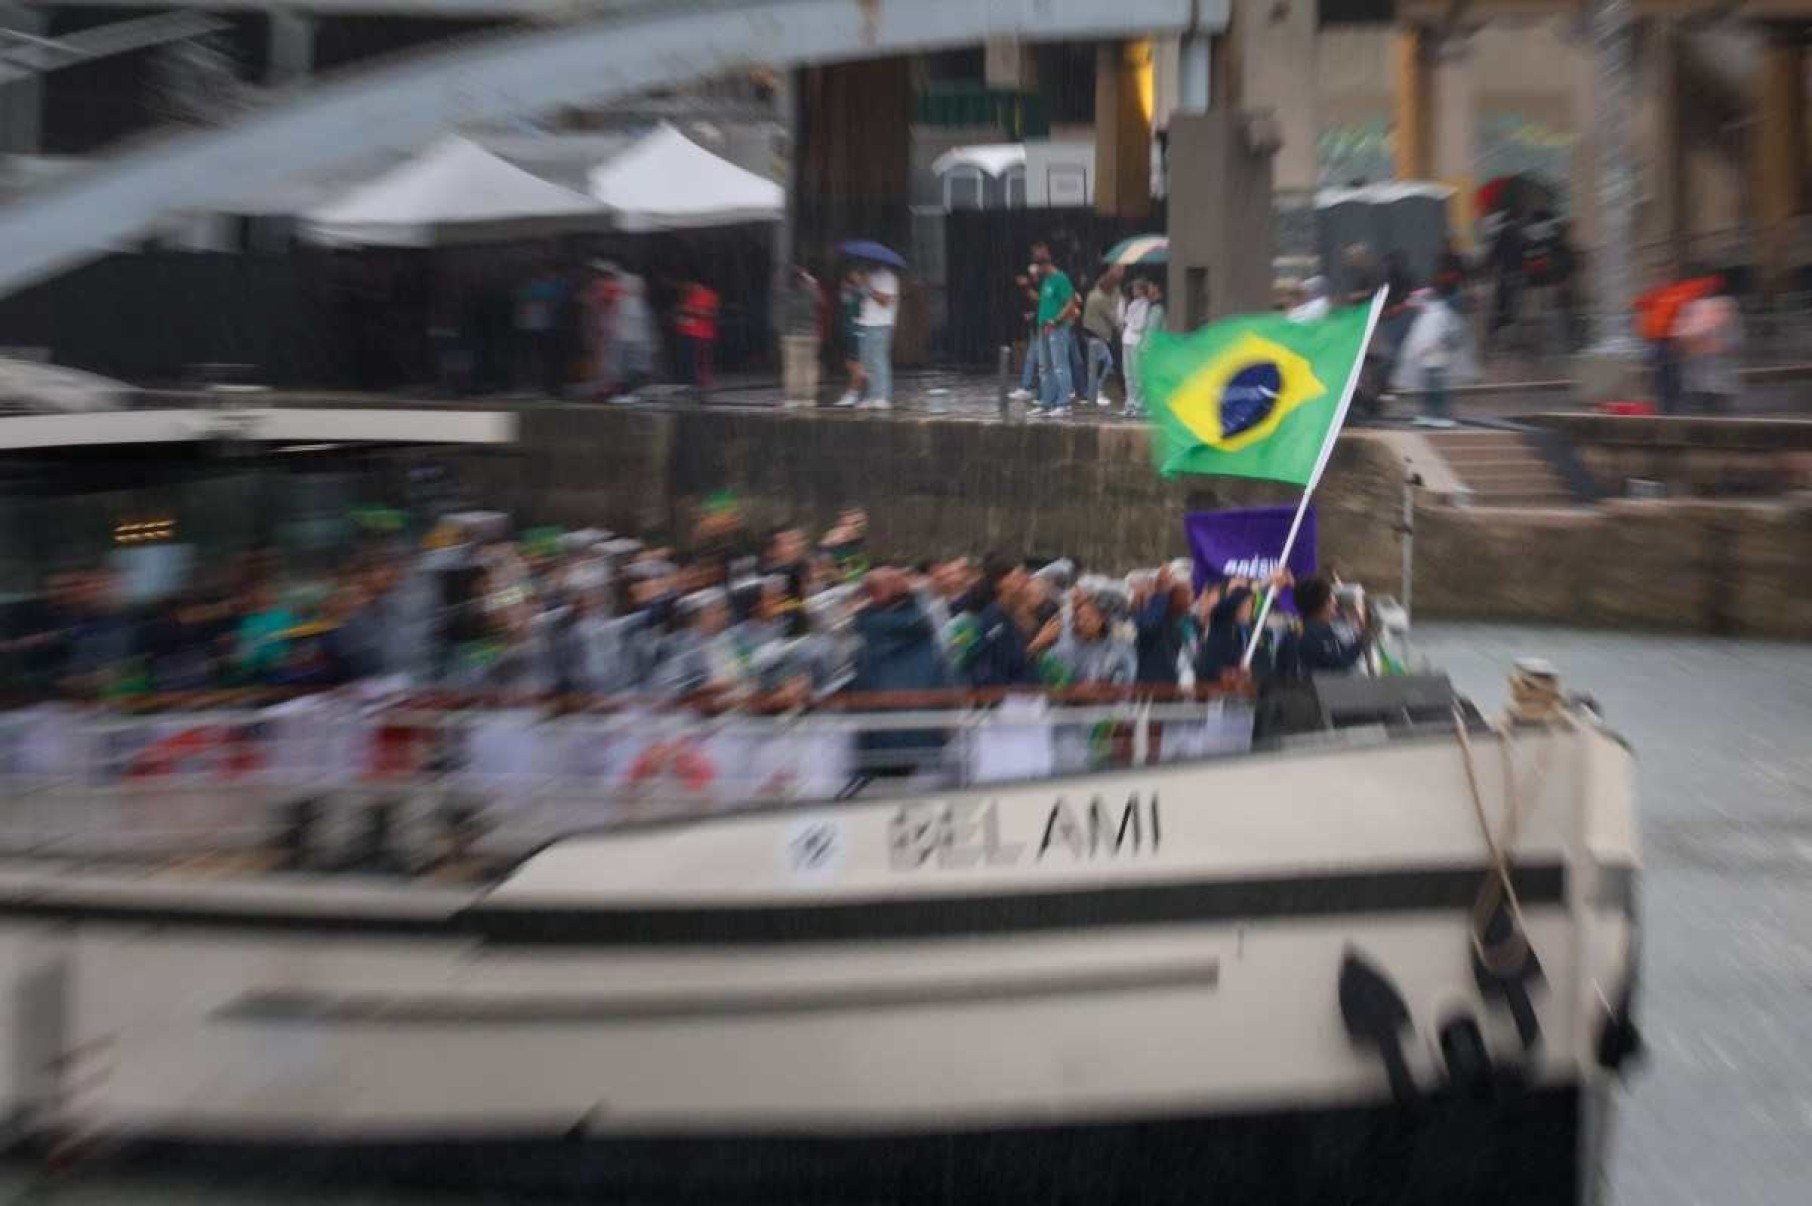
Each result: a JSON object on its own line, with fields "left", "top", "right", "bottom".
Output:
{"left": 1750, "top": 27, "right": 1807, "bottom": 290}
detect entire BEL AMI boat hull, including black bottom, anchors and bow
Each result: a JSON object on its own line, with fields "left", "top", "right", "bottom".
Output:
{"left": 0, "top": 666, "right": 1638, "bottom": 1204}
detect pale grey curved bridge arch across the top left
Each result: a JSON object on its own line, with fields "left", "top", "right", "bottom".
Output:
{"left": 0, "top": 0, "right": 1229, "bottom": 293}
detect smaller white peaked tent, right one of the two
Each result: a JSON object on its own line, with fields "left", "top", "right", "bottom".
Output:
{"left": 591, "top": 123, "right": 786, "bottom": 232}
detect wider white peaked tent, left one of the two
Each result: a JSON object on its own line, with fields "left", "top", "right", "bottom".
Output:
{"left": 303, "top": 136, "right": 607, "bottom": 246}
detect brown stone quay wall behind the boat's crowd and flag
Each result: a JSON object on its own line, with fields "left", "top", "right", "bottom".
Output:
{"left": 442, "top": 406, "right": 1812, "bottom": 637}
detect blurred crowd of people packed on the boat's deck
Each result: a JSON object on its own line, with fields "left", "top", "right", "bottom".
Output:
{"left": 0, "top": 500, "right": 1366, "bottom": 706}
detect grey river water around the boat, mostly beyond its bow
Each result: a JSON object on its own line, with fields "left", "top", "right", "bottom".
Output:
{"left": 0, "top": 625, "right": 1812, "bottom": 1206}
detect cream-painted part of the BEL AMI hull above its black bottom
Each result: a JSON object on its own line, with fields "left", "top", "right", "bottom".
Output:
{"left": 0, "top": 726, "right": 1636, "bottom": 1201}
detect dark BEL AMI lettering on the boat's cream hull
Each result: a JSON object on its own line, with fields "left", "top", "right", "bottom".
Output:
{"left": 888, "top": 791, "right": 1163, "bottom": 871}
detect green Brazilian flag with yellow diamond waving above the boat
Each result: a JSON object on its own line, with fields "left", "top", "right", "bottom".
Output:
{"left": 1138, "top": 302, "right": 1377, "bottom": 489}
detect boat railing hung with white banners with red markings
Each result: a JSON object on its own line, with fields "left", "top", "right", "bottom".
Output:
{"left": 0, "top": 686, "right": 1254, "bottom": 862}
